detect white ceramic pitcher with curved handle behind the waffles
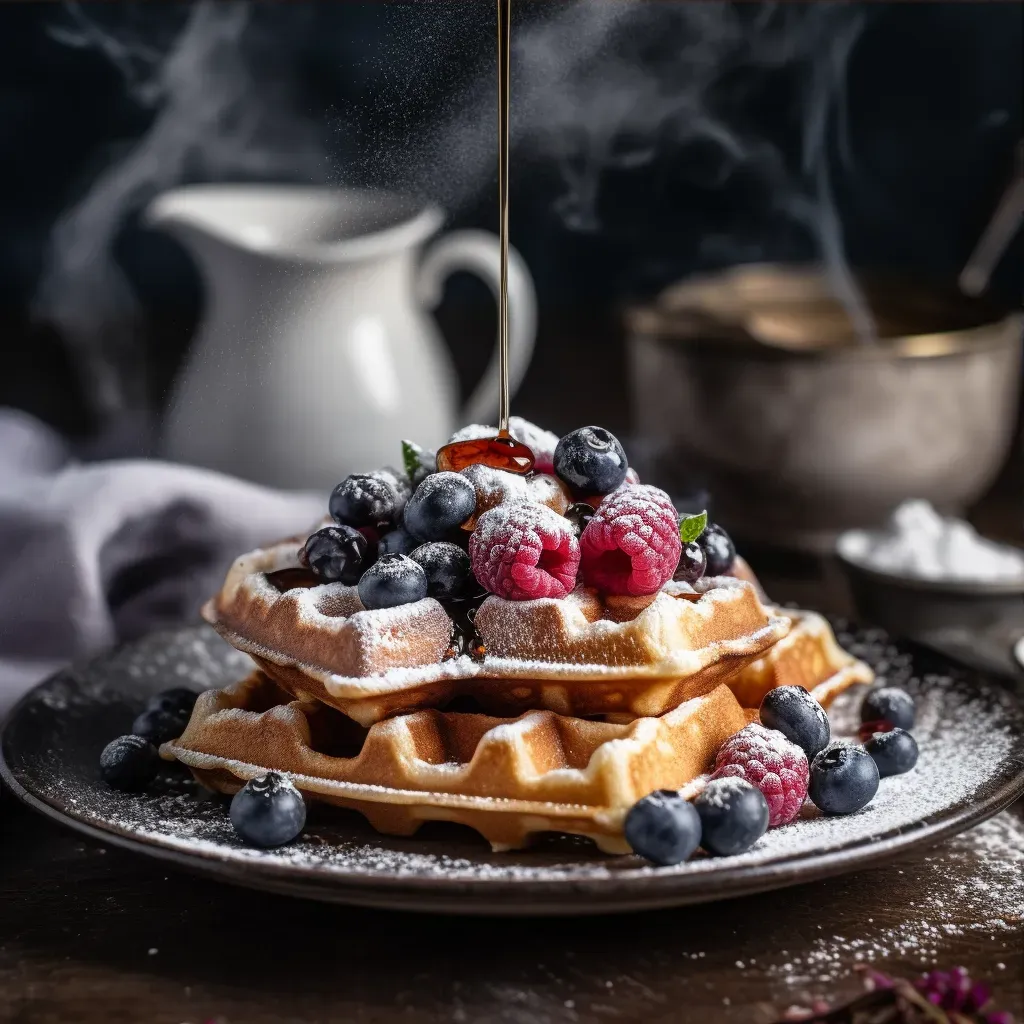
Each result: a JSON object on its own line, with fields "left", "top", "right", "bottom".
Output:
{"left": 145, "top": 185, "right": 537, "bottom": 488}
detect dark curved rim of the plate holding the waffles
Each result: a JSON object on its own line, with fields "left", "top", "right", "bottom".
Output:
{"left": 6, "top": 643, "right": 1024, "bottom": 916}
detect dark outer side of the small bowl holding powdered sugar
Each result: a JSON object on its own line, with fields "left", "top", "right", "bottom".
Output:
{"left": 836, "top": 530, "right": 1024, "bottom": 678}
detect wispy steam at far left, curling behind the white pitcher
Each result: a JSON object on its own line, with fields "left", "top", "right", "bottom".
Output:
{"left": 33, "top": 0, "right": 323, "bottom": 414}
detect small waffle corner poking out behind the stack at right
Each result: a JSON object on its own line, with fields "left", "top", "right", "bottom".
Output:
{"left": 728, "top": 608, "right": 874, "bottom": 708}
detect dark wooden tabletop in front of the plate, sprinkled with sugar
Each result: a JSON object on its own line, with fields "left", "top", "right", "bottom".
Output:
{"left": 0, "top": 795, "right": 1024, "bottom": 1024}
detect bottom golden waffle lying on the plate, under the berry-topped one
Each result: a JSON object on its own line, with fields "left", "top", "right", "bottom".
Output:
{"left": 162, "top": 673, "right": 751, "bottom": 853}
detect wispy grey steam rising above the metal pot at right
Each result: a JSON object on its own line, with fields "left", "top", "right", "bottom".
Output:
{"left": 395, "top": 0, "right": 874, "bottom": 339}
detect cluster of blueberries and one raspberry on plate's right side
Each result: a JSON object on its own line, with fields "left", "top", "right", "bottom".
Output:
{"left": 625, "top": 686, "right": 918, "bottom": 865}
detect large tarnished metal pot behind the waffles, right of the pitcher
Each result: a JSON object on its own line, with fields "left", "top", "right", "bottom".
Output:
{"left": 628, "top": 265, "right": 1021, "bottom": 552}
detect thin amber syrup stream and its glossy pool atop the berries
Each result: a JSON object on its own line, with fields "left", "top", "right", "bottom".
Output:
{"left": 437, "top": 0, "right": 534, "bottom": 473}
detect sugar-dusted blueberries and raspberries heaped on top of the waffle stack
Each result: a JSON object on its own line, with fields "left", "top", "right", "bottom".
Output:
{"left": 300, "top": 417, "right": 736, "bottom": 610}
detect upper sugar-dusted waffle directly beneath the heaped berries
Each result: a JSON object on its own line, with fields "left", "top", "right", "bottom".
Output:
{"left": 204, "top": 542, "right": 790, "bottom": 726}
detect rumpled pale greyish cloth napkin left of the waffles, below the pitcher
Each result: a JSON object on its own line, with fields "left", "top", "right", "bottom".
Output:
{"left": 0, "top": 410, "right": 327, "bottom": 715}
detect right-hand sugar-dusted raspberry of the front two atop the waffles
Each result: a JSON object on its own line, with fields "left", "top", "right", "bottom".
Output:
{"left": 580, "top": 483, "right": 682, "bottom": 595}
